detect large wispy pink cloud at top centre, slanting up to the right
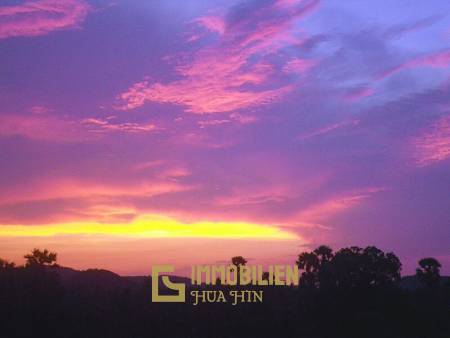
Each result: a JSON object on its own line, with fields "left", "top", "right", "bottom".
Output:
{"left": 118, "top": 1, "right": 318, "bottom": 114}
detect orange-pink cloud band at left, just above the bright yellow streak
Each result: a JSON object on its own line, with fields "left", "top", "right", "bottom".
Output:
{"left": 0, "top": 182, "right": 192, "bottom": 225}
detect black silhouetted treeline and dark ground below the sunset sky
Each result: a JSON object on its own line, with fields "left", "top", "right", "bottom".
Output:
{"left": 0, "top": 246, "right": 450, "bottom": 338}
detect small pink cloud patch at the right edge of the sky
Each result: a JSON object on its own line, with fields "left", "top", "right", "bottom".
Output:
{"left": 412, "top": 115, "right": 450, "bottom": 167}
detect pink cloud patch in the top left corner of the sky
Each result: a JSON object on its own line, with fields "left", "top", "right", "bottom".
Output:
{"left": 0, "top": 0, "right": 90, "bottom": 39}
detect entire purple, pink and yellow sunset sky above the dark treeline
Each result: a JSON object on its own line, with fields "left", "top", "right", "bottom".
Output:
{"left": 0, "top": 0, "right": 450, "bottom": 275}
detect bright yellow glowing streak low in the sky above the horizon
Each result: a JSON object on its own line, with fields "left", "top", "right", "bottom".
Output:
{"left": 0, "top": 216, "right": 298, "bottom": 240}
